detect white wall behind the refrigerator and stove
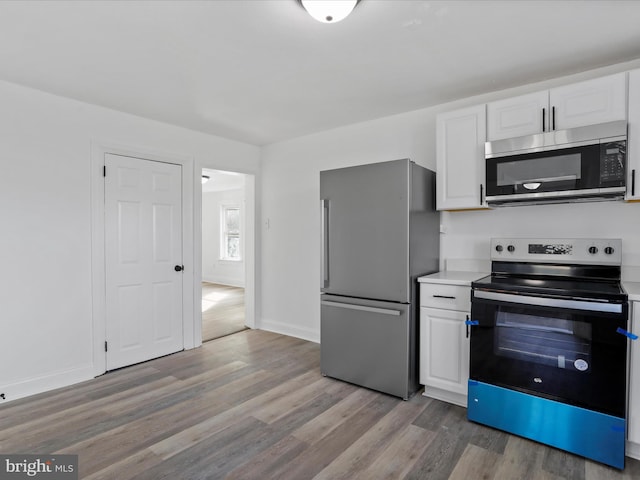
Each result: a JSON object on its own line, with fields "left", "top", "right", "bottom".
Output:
{"left": 260, "top": 60, "right": 640, "bottom": 341}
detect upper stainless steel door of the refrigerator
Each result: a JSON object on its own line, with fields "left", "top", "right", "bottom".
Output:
{"left": 320, "top": 160, "right": 410, "bottom": 302}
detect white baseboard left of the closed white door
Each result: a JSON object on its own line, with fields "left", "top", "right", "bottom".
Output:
{"left": 0, "top": 365, "right": 95, "bottom": 405}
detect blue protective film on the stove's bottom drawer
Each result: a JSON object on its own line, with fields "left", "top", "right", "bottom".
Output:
{"left": 467, "top": 380, "right": 626, "bottom": 469}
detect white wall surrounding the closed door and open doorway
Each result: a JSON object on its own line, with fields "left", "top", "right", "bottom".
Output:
{"left": 0, "top": 82, "right": 260, "bottom": 400}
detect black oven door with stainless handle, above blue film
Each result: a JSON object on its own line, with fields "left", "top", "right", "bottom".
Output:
{"left": 469, "top": 290, "right": 628, "bottom": 417}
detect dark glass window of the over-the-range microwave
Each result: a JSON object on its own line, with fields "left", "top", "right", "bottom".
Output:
{"left": 496, "top": 153, "right": 581, "bottom": 190}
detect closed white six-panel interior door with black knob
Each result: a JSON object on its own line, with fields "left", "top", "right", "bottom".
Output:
{"left": 105, "top": 154, "right": 184, "bottom": 370}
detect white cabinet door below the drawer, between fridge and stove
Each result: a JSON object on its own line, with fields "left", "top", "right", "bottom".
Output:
{"left": 420, "top": 308, "right": 469, "bottom": 395}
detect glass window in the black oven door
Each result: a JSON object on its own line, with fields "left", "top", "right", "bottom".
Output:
{"left": 494, "top": 307, "right": 591, "bottom": 373}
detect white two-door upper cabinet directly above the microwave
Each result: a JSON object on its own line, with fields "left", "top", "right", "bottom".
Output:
{"left": 487, "top": 73, "right": 627, "bottom": 141}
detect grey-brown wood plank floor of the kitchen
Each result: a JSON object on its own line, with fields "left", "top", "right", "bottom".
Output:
{"left": 0, "top": 330, "right": 640, "bottom": 480}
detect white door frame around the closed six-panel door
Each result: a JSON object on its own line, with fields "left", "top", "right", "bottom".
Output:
{"left": 90, "top": 140, "right": 194, "bottom": 376}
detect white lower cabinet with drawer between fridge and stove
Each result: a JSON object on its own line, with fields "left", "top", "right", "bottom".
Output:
{"left": 420, "top": 284, "right": 471, "bottom": 407}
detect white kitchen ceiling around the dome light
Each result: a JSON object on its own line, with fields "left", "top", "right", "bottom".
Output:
{"left": 0, "top": 0, "right": 640, "bottom": 145}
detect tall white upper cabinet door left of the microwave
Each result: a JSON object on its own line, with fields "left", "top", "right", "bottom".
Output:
{"left": 436, "top": 105, "right": 486, "bottom": 210}
